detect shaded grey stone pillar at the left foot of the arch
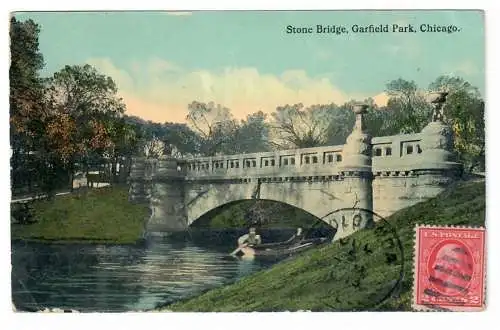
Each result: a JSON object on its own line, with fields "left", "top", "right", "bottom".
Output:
{"left": 147, "top": 156, "right": 187, "bottom": 233}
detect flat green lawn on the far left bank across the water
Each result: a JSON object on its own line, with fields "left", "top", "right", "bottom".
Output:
{"left": 11, "top": 187, "right": 149, "bottom": 243}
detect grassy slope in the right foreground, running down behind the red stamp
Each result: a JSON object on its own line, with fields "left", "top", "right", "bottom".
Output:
{"left": 165, "top": 182, "right": 485, "bottom": 312}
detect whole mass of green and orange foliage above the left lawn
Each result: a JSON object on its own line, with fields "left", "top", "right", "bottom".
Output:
{"left": 9, "top": 17, "right": 132, "bottom": 195}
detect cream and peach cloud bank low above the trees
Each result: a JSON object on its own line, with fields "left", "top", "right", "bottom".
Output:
{"left": 87, "top": 58, "right": 384, "bottom": 122}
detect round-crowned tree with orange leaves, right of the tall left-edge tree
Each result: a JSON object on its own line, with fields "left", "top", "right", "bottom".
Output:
{"left": 46, "top": 64, "right": 125, "bottom": 184}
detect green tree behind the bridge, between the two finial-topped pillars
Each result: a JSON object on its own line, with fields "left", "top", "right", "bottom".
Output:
{"left": 386, "top": 78, "right": 432, "bottom": 134}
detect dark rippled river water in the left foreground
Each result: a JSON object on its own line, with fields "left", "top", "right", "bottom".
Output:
{"left": 12, "top": 233, "right": 288, "bottom": 312}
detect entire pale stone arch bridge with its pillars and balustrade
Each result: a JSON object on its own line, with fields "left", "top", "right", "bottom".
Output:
{"left": 129, "top": 95, "right": 462, "bottom": 239}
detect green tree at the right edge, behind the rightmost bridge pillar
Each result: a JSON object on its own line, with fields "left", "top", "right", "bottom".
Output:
{"left": 429, "top": 76, "right": 485, "bottom": 172}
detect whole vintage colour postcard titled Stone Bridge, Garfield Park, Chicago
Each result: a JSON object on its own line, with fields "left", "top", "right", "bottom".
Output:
{"left": 10, "top": 10, "right": 487, "bottom": 313}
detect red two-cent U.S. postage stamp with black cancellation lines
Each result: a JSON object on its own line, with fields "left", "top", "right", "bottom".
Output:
{"left": 413, "top": 226, "right": 486, "bottom": 311}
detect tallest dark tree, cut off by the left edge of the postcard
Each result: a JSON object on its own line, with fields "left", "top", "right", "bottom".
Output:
{"left": 9, "top": 17, "right": 47, "bottom": 190}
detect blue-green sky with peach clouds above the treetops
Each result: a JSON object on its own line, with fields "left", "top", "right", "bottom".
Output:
{"left": 15, "top": 11, "right": 485, "bottom": 122}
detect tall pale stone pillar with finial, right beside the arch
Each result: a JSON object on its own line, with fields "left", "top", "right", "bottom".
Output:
{"left": 335, "top": 104, "right": 373, "bottom": 240}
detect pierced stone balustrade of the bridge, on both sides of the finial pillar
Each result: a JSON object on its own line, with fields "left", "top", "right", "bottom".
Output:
{"left": 186, "top": 133, "right": 422, "bottom": 177}
